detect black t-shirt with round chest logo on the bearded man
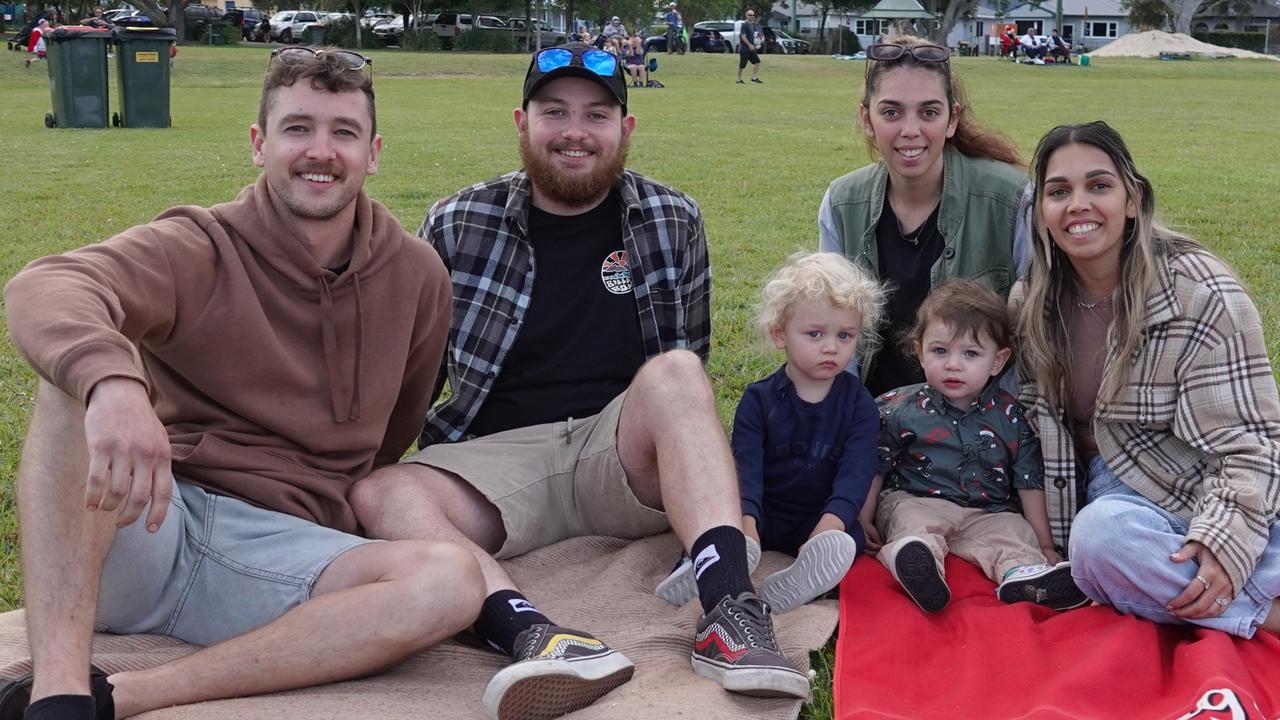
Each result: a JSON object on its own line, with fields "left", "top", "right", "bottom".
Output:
{"left": 467, "top": 191, "right": 644, "bottom": 436}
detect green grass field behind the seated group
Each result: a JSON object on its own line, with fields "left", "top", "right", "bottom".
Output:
{"left": 0, "top": 46, "right": 1280, "bottom": 717}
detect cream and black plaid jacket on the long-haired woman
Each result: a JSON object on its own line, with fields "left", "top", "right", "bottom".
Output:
{"left": 1010, "top": 252, "right": 1280, "bottom": 592}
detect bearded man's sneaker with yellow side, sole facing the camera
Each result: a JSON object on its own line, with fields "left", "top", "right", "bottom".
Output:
{"left": 484, "top": 624, "right": 635, "bottom": 720}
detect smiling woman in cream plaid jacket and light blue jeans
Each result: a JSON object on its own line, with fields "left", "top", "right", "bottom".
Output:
{"left": 1010, "top": 122, "right": 1280, "bottom": 637}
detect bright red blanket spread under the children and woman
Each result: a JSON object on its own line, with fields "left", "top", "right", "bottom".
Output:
{"left": 833, "top": 556, "right": 1280, "bottom": 720}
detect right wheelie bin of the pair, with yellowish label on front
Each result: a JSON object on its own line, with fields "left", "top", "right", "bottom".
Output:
{"left": 111, "top": 27, "right": 178, "bottom": 128}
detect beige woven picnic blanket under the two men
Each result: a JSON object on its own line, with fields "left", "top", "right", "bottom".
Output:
{"left": 0, "top": 533, "right": 837, "bottom": 720}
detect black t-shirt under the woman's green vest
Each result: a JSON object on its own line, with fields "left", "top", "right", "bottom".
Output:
{"left": 863, "top": 193, "right": 942, "bottom": 396}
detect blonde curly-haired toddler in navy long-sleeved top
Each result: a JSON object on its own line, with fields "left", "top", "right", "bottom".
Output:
{"left": 657, "top": 252, "right": 884, "bottom": 612}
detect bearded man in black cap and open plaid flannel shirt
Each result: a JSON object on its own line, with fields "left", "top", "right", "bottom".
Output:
{"left": 351, "top": 44, "right": 809, "bottom": 720}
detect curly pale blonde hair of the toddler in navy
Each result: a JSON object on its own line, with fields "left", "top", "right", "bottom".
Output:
{"left": 755, "top": 252, "right": 886, "bottom": 356}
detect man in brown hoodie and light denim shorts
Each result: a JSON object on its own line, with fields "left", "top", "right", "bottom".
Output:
{"left": 0, "top": 47, "right": 483, "bottom": 719}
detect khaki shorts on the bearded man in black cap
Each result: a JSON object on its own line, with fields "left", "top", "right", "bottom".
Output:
{"left": 403, "top": 392, "right": 669, "bottom": 557}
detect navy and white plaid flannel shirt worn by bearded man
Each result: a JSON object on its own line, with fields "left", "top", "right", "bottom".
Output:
{"left": 417, "top": 170, "right": 712, "bottom": 447}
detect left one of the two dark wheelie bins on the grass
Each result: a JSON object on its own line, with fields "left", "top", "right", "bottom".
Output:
{"left": 45, "top": 26, "right": 111, "bottom": 128}
